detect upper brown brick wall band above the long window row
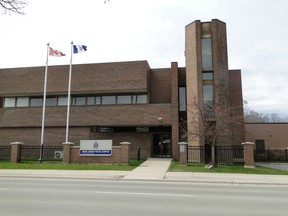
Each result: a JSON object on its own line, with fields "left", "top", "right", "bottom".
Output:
{"left": 0, "top": 61, "right": 150, "bottom": 96}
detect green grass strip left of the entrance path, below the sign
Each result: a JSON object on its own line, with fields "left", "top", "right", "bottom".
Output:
{"left": 0, "top": 159, "right": 143, "bottom": 171}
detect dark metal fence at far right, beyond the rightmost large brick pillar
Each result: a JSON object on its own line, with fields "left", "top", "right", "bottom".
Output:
{"left": 254, "top": 149, "right": 288, "bottom": 162}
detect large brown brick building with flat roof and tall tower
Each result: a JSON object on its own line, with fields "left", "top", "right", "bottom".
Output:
{"left": 0, "top": 20, "right": 244, "bottom": 159}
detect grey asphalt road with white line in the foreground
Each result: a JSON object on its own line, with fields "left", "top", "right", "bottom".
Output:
{"left": 0, "top": 178, "right": 288, "bottom": 216}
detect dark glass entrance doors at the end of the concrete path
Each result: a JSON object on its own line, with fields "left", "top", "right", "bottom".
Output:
{"left": 152, "top": 133, "right": 172, "bottom": 158}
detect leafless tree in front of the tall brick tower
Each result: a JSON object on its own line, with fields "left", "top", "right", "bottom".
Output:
{"left": 179, "top": 93, "right": 245, "bottom": 166}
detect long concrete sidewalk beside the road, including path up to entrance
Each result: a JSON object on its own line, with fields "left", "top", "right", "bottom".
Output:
{"left": 0, "top": 158, "right": 288, "bottom": 185}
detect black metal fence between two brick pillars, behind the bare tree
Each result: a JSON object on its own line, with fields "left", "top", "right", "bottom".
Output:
{"left": 187, "top": 145, "right": 244, "bottom": 165}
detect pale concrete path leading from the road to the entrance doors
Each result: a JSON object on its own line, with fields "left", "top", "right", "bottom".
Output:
{"left": 123, "top": 158, "right": 172, "bottom": 180}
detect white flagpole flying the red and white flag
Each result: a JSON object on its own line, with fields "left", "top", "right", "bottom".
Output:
{"left": 39, "top": 43, "right": 50, "bottom": 163}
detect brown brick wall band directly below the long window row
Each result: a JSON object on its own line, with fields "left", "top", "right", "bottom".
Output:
{"left": 0, "top": 104, "right": 171, "bottom": 127}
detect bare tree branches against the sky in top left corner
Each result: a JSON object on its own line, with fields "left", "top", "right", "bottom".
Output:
{"left": 0, "top": 0, "right": 28, "bottom": 15}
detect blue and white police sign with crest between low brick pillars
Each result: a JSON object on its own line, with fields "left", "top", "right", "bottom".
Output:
{"left": 80, "top": 140, "right": 112, "bottom": 156}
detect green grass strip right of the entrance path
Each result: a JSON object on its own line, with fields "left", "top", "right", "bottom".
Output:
{"left": 169, "top": 161, "right": 288, "bottom": 175}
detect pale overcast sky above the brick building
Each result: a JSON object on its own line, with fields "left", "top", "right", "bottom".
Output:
{"left": 0, "top": 0, "right": 288, "bottom": 117}
